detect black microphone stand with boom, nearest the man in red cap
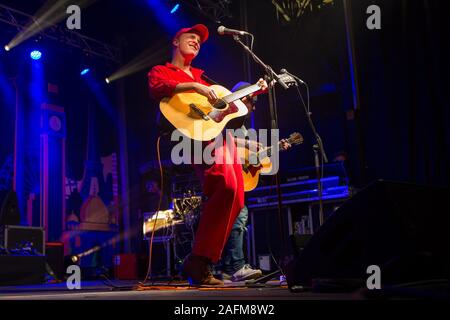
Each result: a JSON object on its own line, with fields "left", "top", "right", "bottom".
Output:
{"left": 233, "top": 35, "right": 289, "bottom": 284}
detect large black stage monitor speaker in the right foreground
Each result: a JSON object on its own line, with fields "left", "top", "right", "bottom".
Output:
{"left": 286, "top": 180, "right": 450, "bottom": 288}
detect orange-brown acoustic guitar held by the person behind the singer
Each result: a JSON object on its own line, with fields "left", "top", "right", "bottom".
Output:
{"left": 237, "top": 132, "right": 303, "bottom": 192}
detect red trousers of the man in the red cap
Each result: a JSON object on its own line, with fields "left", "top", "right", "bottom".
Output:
{"left": 192, "top": 135, "right": 244, "bottom": 263}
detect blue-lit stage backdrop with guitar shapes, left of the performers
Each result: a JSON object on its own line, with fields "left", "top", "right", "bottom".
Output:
{"left": 0, "top": 26, "right": 123, "bottom": 267}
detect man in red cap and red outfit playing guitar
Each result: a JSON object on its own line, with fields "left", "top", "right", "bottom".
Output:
{"left": 148, "top": 24, "right": 244, "bottom": 285}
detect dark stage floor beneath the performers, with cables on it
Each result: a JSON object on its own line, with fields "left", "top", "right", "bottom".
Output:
{"left": 0, "top": 281, "right": 361, "bottom": 300}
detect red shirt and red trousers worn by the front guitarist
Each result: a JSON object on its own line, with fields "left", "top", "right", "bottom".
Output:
{"left": 148, "top": 63, "right": 244, "bottom": 262}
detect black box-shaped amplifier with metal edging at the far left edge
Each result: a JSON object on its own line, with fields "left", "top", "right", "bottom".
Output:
{"left": 0, "top": 225, "right": 45, "bottom": 255}
